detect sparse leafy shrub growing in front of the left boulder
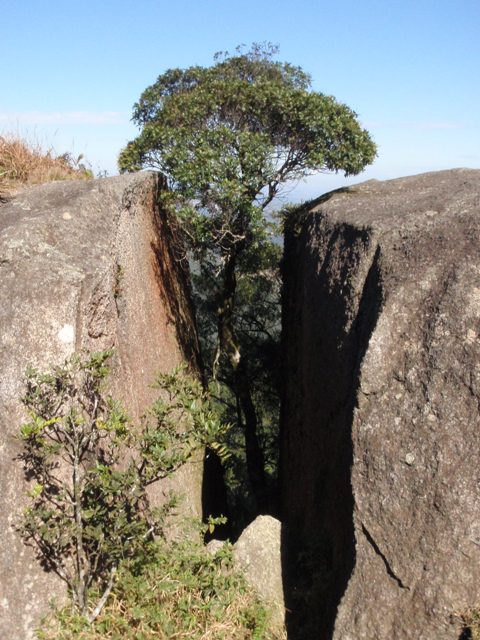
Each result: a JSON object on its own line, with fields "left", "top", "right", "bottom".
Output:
{"left": 19, "top": 352, "right": 226, "bottom": 622}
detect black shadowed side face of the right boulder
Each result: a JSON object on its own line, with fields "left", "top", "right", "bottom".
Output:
{"left": 281, "top": 216, "right": 383, "bottom": 640}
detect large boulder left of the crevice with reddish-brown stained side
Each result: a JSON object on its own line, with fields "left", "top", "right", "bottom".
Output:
{"left": 0, "top": 173, "right": 202, "bottom": 640}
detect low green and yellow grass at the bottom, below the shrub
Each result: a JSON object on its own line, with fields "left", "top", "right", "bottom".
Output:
{"left": 37, "top": 541, "right": 286, "bottom": 640}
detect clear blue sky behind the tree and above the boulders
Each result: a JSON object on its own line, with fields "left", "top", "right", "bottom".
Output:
{"left": 0, "top": 0, "right": 480, "bottom": 200}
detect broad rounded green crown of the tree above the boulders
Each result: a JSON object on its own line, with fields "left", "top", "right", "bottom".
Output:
{"left": 119, "top": 45, "right": 375, "bottom": 237}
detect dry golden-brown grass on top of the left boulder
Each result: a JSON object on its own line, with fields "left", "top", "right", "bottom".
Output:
{"left": 0, "top": 134, "right": 92, "bottom": 195}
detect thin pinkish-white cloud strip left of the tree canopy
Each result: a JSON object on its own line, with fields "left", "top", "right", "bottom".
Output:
{"left": 0, "top": 111, "right": 128, "bottom": 125}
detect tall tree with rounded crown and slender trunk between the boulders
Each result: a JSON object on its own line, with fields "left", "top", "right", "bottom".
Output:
{"left": 119, "top": 45, "right": 376, "bottom": 509}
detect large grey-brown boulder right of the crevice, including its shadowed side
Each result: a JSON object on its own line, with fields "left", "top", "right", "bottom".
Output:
{"left": 282, "top": 169, "right": 480, "bottom": 640}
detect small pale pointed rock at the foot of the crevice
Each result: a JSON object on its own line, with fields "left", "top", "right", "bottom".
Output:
{"left": 233, "top": 516, "right": 285, "bottom": 630}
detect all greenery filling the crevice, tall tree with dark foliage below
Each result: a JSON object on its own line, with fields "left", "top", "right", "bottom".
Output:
{"left": 119, "top": 44, "right": 376, "bottom": 520}
